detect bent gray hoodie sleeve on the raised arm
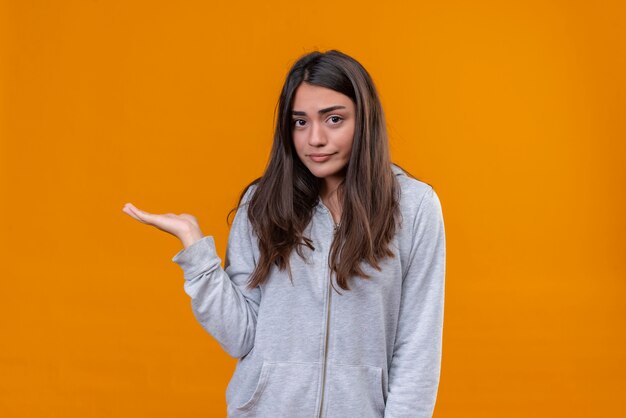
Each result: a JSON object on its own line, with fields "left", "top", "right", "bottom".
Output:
{"left": 172, "top": 187, "right": 261, "bottom": 358}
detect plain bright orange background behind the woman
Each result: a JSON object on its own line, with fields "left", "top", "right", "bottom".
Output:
{"left": 0, "top": 0, "right": 626, "bottom": 418}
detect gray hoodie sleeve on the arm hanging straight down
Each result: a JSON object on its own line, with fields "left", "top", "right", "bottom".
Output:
{"left": 385, "top": 187, "right": 446, "bottom": 418}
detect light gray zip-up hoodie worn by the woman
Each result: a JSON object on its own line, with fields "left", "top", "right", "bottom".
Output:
{"left": 172, "top": 166, "right": 446, "bottom": 418}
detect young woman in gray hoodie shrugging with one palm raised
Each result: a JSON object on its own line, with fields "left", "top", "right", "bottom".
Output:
{"left": 124, "top": 51, "right": 446, "bottom": 418}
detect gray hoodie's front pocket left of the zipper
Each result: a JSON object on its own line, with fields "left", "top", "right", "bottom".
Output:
{"left": 231, "top": 362, "right": 320, "bottom": 417}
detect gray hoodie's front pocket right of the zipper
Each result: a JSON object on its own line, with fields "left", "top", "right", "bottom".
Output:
{"left": 324, "top": 363, "right": 385, "bottom": 418}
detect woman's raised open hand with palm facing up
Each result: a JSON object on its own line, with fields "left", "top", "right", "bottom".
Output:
{"left": 122, "top": 203, "right": 204, "bottom": 248}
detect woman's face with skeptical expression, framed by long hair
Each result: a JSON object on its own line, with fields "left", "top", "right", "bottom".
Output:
{"left": 292, "top": 83, "right": 356, "bottom": 188}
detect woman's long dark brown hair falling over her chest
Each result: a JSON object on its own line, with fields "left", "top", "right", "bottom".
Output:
{"left": 232, "top": 50, "right": 400, "bottom": 290}
